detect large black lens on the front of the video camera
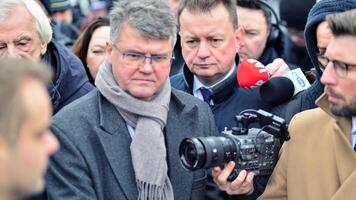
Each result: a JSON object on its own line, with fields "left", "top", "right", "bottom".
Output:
{"left": 179, "top": 135, "right": 239, "bottom": 170}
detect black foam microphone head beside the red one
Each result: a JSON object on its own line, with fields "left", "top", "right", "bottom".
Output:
{"left": 260, "top": 76, "right": 295, "bottom": 105}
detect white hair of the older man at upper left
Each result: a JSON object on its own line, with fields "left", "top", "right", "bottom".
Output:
{"left": 0, "top": 0, "right": 53, "bottom": 44}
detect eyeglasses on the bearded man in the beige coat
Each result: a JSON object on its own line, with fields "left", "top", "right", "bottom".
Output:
{"left": 317, "top": 54, "right": 356, "bottom": 78}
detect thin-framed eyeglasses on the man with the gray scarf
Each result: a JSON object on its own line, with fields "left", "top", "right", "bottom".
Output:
{"left": 112, "top": 43, "right": 174, "bottom": 68}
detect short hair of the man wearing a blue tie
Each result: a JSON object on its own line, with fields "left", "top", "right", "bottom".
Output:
{"left": 178, "top": 0, "right": 238, "bottom": 29}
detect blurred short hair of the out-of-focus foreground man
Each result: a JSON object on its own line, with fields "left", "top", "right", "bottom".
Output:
{"left": 0, "top": 58, "right": 52, "bottom": 145}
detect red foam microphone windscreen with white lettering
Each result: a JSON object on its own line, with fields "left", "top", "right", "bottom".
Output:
{"left": 237, "top": 59, "right": 270, "bottom": 88}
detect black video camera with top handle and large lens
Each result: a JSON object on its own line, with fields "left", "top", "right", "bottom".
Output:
{"left": 179, "top": 110, "right": 290, "bottom": 181}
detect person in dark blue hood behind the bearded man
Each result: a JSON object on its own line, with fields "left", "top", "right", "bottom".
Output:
{"left": 272, "top": 0, "right": 356, "bottom": 122}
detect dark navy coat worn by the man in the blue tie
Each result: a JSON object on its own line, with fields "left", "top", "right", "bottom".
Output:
{"left": 171, "top": 55, "right": 271, "bottom": 200}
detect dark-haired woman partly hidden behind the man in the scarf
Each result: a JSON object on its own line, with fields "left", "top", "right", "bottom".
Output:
{"left": 72, "top": 17, "right": 110, "bottom": 84}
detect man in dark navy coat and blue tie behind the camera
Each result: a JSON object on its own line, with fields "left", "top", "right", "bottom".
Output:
{"left": 171, "top": 0, "right": 290, "bottom": 199}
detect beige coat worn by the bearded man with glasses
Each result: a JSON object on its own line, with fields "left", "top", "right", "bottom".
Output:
{"left": 259, "top": 95, "right": 356, "bottom": 200}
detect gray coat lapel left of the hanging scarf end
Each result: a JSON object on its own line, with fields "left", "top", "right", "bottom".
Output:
{"left": 96, "top": 96, "right": 138, "bottom": 200}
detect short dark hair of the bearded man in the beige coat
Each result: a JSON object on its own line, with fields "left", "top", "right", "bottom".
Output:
{"left": 326, "top": 9, "right": 356, "bottom": 36}
